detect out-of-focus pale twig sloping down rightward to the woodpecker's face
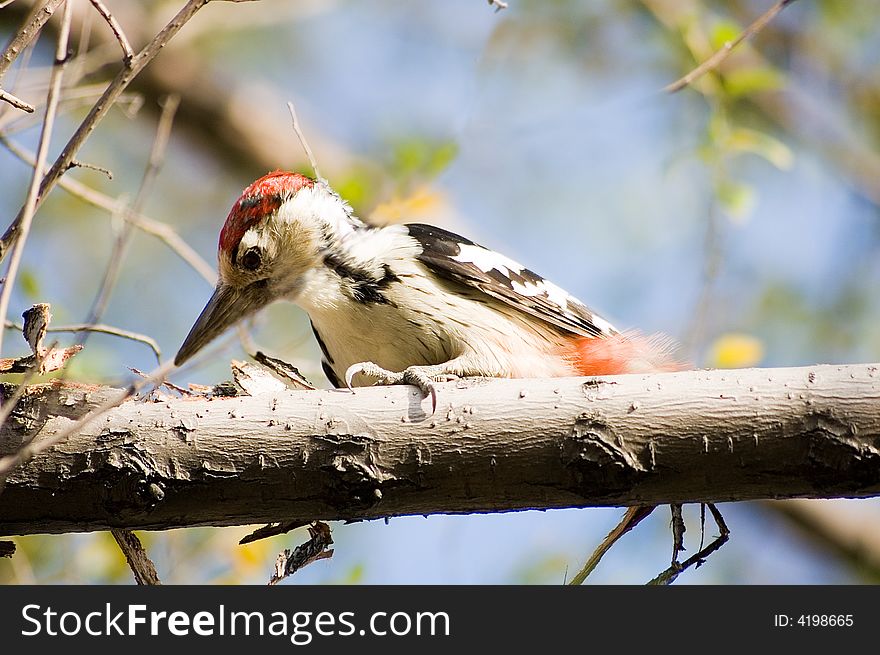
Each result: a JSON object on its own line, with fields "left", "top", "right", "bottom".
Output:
{"left": 0, "top": 135, "right": 217, "bottom": 286}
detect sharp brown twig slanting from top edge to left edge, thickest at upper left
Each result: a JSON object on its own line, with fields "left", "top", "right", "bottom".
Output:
{"left": 0, "top": 0, "right": 218, "bottom": 261}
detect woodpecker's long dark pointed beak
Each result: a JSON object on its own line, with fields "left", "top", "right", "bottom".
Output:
{"left": 174, "top": 280, "right": 271, "bottom": 366}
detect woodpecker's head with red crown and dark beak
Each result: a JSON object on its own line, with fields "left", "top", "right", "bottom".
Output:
{"left": 174, "top": 171, "right": 358, "bottom": 366}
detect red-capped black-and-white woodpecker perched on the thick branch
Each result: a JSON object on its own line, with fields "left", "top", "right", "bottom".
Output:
{"left": 174, "top": 171, "right": 681, "bottom": 407}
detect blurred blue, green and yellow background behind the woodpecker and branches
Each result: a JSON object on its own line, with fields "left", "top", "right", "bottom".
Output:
{"left": 0, "top": 0, "right": 880, "bottom": 584}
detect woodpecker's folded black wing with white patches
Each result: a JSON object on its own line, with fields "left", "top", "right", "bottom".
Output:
{"left": 406, "top": 223, "right": 618, "bottom": 337}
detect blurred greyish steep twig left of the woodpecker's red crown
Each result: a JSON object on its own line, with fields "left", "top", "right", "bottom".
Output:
{"left": 78, "top": 96, "right": 180, "bottom": 352}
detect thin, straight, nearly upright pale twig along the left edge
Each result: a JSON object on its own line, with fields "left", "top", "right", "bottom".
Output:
{"left": 0, "top": 0, "right": 73, "bottom": 352}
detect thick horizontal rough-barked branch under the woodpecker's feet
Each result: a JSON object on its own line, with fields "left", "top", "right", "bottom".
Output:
{"left": 0, "top": 364, "right": 880, "bottom": 534}
